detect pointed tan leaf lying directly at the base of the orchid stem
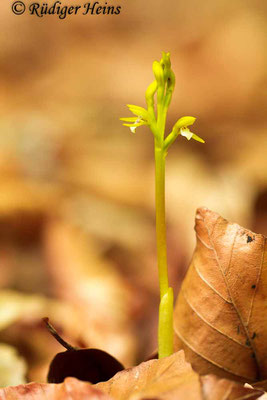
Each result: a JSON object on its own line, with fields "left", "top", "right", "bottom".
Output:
{"left": 95, "top": 351, "right": 202, "bottom": 400}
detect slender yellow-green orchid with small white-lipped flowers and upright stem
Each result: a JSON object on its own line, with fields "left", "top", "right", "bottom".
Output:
{"left": 120, "top": 52, "right": 205, "bottom": 358}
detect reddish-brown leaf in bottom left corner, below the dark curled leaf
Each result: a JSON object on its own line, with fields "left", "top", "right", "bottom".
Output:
{"left": 0, "top": 378, "right": 111, "bottom": 400}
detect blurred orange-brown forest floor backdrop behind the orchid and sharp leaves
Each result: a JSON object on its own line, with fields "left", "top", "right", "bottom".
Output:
{"left": 0, "top": 0, "right": 267, "bottom": 386}
